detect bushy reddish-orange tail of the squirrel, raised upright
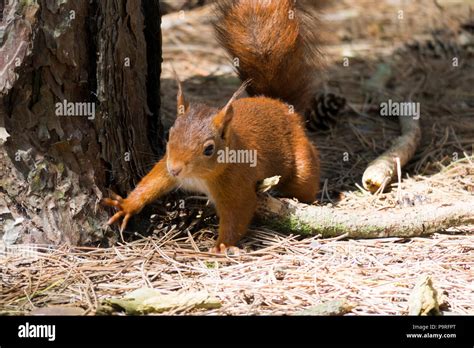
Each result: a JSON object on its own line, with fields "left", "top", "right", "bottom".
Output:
{"left": 214, "top": 0, "right": 325, "bottom": 112}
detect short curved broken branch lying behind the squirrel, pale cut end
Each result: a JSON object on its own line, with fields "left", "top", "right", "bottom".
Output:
{"left": 362, "top": 117, "right": 421, "bottom": 193}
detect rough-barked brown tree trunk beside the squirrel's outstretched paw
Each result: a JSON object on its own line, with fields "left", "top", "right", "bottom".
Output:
{"left": 0, "top": 0, "right": 163, "bottom": 244}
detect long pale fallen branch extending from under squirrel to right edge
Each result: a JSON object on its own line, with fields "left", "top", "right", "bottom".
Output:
{"left": 256, "top": 194, "right": 474, "bottom": 238}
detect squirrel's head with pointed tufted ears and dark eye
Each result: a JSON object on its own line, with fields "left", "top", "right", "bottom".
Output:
{"left": 166, "top": 79, "right": 247, "bottom": 178}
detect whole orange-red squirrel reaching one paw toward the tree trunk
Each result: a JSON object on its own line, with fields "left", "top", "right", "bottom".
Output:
{"left": 103, "top": 0, "right": 320, "bottom": 253}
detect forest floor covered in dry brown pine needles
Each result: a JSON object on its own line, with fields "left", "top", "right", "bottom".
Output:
{"left": 0, "top": 0, "right": 474, "bottom": 315}
